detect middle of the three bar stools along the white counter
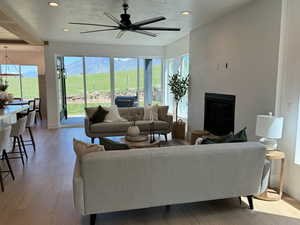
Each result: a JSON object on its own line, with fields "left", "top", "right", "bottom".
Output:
{"left": 8, "top": 116, "right": 28, "bottom": 166}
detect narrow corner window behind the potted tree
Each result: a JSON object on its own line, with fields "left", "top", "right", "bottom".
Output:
{"left": 164, "top": 55, "right": 189, "bottom": 119}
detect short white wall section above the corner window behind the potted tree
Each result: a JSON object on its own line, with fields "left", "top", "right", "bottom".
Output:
{"left": 164, "top": 35, "right": 190, "bottom": 58}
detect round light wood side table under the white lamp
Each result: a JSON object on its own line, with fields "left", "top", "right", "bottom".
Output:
{"left": 255, "top": 151, "right": 285, "bottom": 201}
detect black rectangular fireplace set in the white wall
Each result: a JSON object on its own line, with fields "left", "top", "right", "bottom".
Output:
{"left": 204, "top": 93, "right": 235, "bottom": 136}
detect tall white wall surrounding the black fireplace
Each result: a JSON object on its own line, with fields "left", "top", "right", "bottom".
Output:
{"left": 189, "top": 0, "right": 281, "bottom": 139}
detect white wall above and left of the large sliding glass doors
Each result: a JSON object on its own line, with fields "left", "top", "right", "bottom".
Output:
{"left": 45, "top": 42, "right": 164, "bottom": 128}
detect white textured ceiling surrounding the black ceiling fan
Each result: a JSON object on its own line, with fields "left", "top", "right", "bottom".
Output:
{"left": 0, "top": 0, "right": 251, "bottom": 45}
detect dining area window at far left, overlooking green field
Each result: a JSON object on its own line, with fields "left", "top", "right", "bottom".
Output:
{"left": 1, "top": 65, "right": 39, "bottom": 99}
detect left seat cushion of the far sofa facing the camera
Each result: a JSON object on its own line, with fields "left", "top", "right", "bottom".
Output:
{"left": 91, "top": 122, "right": 132, "bottom": 133}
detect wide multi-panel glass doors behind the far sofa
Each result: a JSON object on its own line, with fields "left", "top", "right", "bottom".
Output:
{"left": 60, "top": 56, "right": 163, "bottom": 120}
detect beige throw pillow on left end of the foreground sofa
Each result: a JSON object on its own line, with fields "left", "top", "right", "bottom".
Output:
{"left": 73, "top": 138, "right": 105, "bottom": 160}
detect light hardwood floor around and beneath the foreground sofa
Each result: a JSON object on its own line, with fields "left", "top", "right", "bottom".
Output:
{"left": 0, "top": 128, "right": 300, "bottom": 225}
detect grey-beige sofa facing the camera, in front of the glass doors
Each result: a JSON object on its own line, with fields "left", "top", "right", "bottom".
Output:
{"left": 84, "top": 106, "right": 173, "bottom": 142}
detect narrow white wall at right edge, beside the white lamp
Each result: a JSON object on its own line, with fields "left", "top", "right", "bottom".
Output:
{"left": 278, "top": 0, "right": 300, "bottom": 200}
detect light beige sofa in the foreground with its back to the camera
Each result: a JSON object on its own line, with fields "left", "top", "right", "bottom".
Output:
{"left": 73, "top": 142, "right": 270, "bottom": 225}
